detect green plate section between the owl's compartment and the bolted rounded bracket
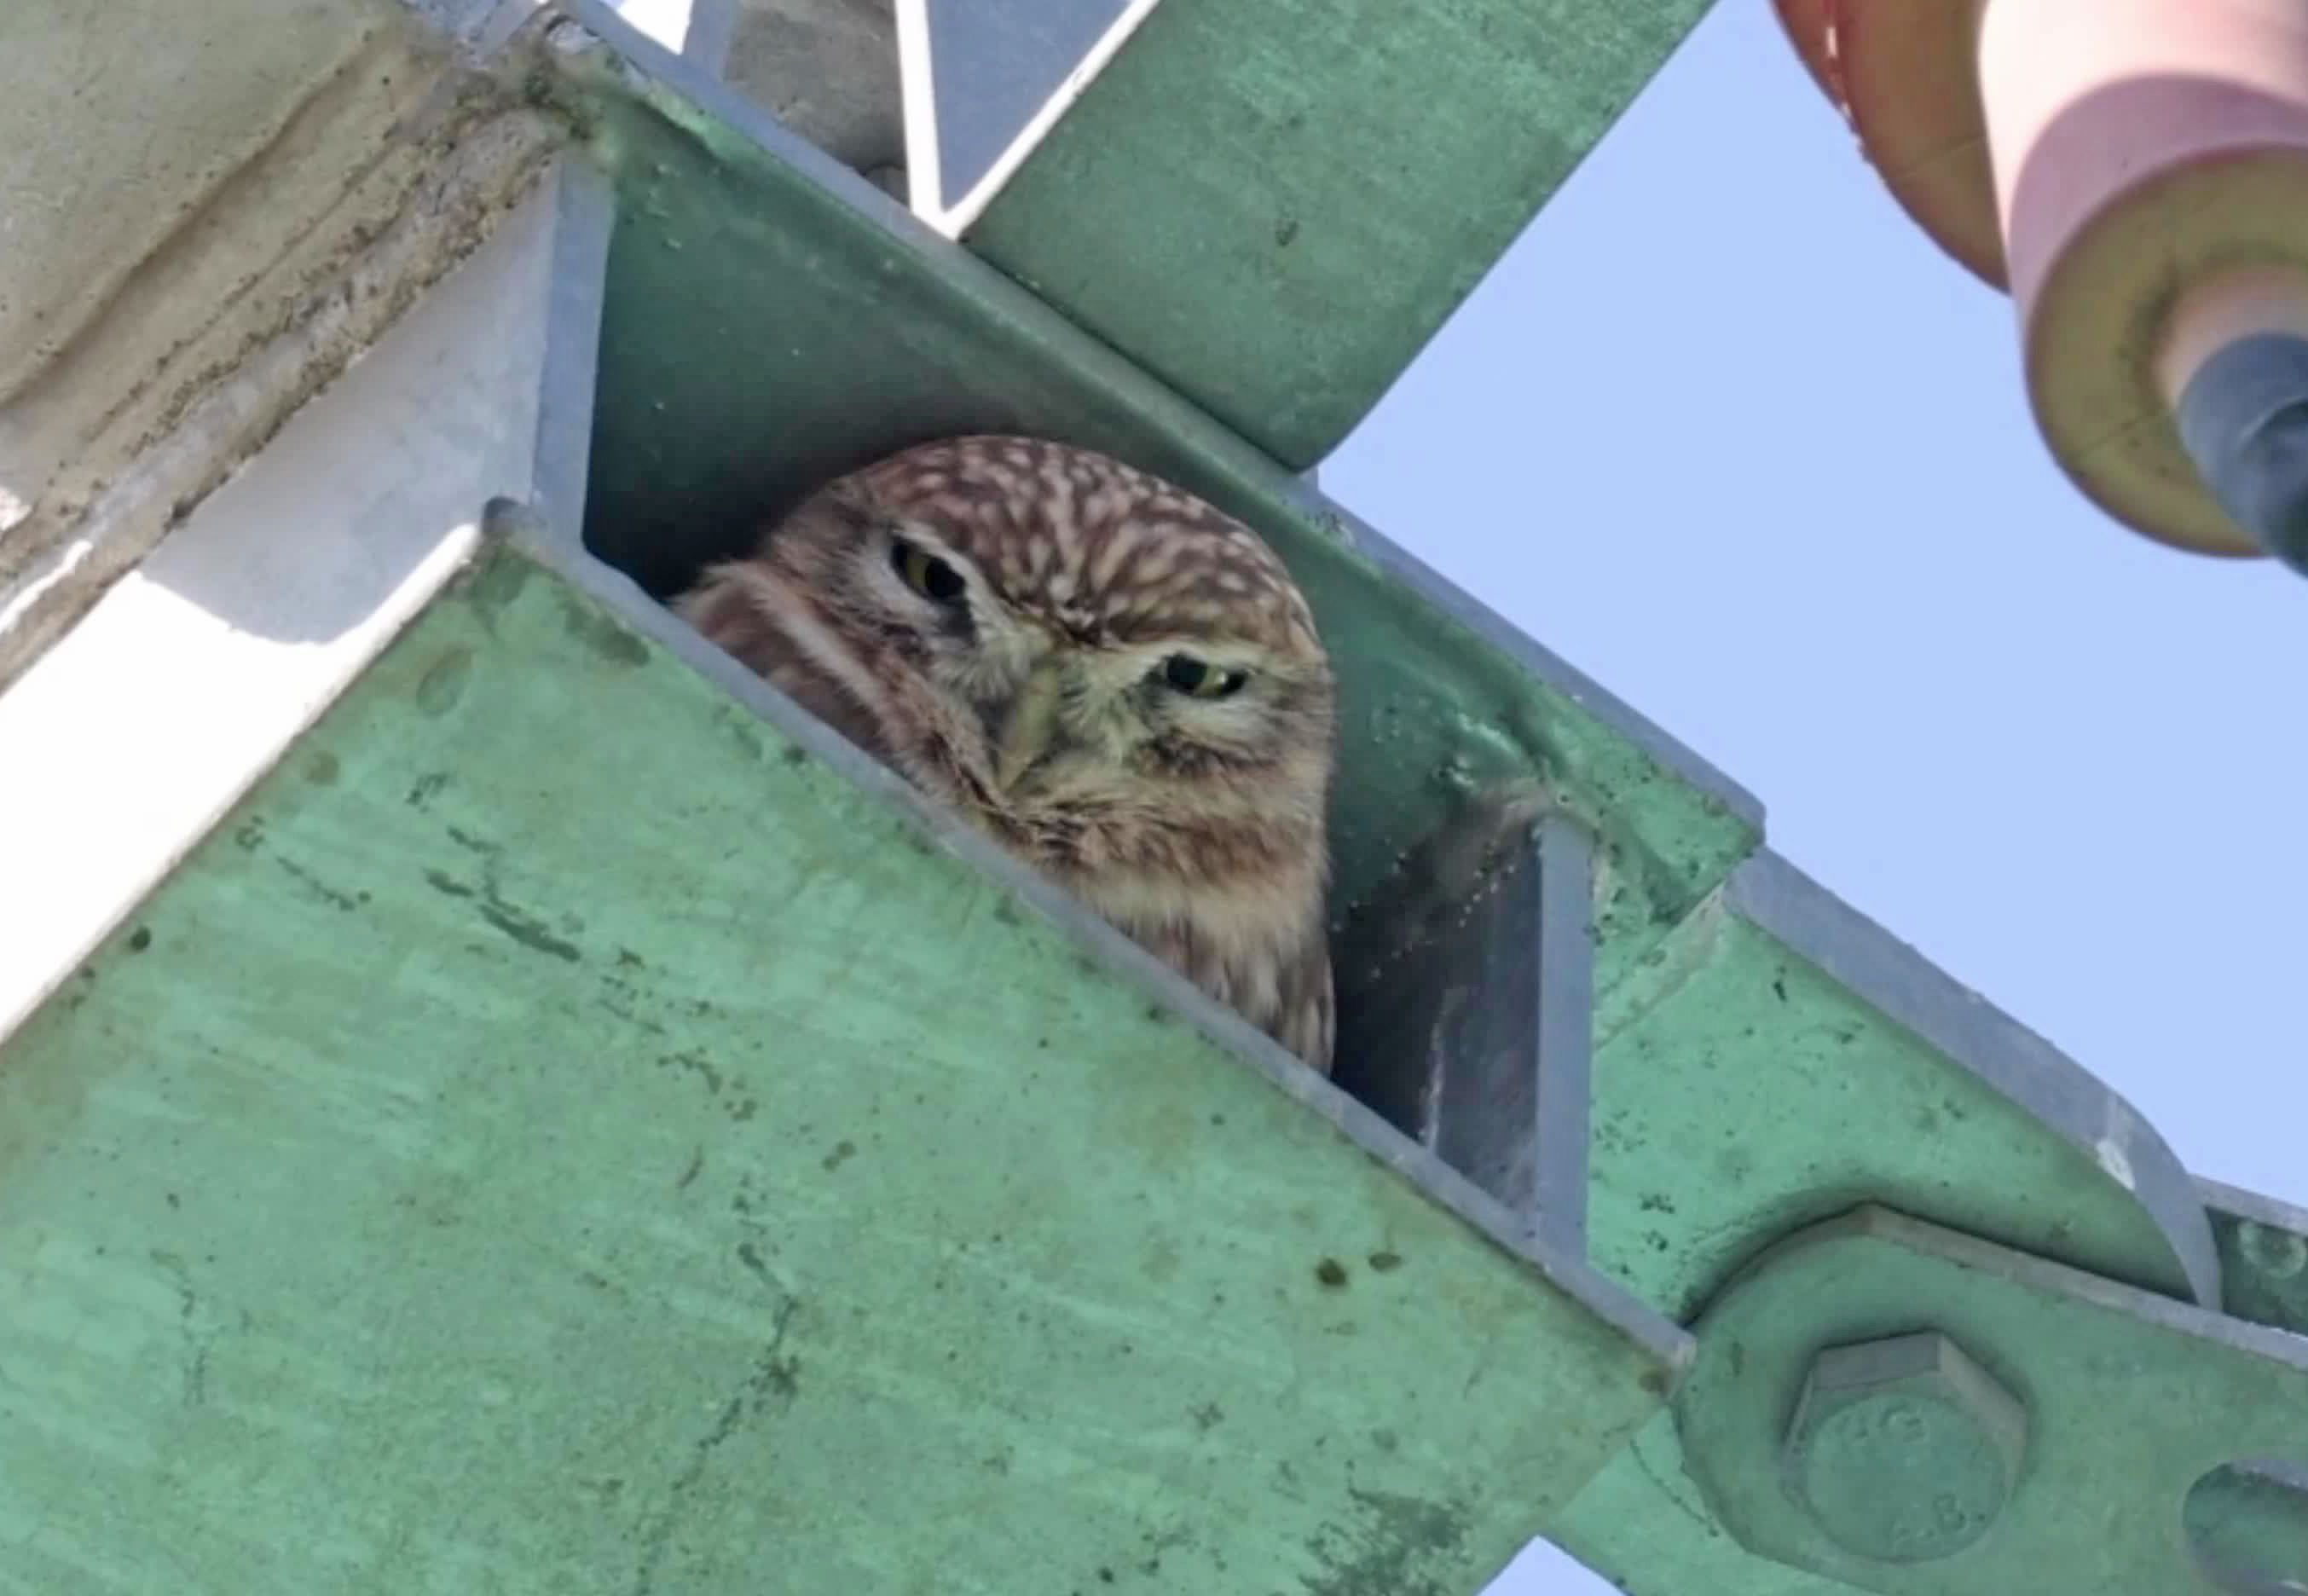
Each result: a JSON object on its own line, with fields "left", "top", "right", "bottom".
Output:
{"left": 1588, "top": 899, "right": 2186, "bottom": 1319}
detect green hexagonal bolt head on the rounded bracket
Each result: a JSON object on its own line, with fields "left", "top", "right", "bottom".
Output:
{"left": 1779, "top": 1333, "right": 2027, "bottom": 1564}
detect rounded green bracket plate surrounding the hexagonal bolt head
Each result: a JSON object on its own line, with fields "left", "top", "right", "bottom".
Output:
{"left": 1675, "top": 1206, "right": 2308, "bottom": 1596}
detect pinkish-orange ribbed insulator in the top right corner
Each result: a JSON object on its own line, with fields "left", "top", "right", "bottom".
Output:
{"left": 1775, "top": 0, "right": 2308, "bottom": 564}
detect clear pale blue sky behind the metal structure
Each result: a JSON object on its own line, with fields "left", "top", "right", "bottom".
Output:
{"left": 1322, "top": 0, "right": 2308, "bottom": 1596}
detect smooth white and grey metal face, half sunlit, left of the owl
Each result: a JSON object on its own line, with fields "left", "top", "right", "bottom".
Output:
{"left": 0, "top": 155, "right": 604, "bottom": 1031}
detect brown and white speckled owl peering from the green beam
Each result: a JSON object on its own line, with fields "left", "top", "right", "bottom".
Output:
{"left": 676, "top": 438, "right": 1334, "bottom": 1070}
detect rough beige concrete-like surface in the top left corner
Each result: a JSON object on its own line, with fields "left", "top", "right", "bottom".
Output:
{"left": 0, "top": 0, "right": 561, "bottom": 685}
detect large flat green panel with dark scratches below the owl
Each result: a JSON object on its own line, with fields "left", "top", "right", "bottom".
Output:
{"left": 0, "top": 549, "right": 1671, "bottom": 1596}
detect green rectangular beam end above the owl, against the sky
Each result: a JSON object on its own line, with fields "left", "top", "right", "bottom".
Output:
{"left": 965, "top": 0, "right": 1705, "bottom": 468}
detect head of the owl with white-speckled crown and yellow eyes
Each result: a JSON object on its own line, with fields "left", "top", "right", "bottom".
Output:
{"left": 715, "top": 438, "right": 1334, "bottom": 825}
